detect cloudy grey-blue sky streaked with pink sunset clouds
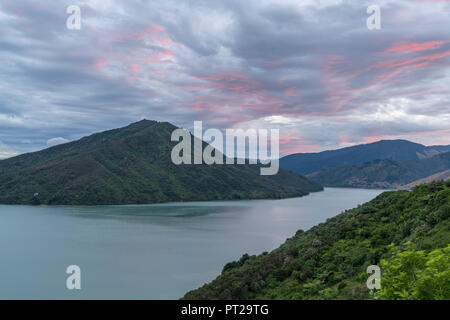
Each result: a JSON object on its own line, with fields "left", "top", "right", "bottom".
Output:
{"left": 0, "top": 0, "right": 450, "bottom": 158}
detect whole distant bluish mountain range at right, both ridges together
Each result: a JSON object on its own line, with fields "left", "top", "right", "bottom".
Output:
{"left": 280, "top": 140, "right": 450, "bottom": 189}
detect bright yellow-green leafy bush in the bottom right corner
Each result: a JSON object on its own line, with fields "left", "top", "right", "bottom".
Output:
{"left": 373, "top": 242, "right": 450, "bottom": 300}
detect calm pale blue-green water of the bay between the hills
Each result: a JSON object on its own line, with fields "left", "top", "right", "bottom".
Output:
{"left": 0, "top": 188, "right": 381, "bottom": 299}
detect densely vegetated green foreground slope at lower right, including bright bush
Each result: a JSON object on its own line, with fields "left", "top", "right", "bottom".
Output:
{"left": 184, "top": 180, "right": 450, "bottom": 299}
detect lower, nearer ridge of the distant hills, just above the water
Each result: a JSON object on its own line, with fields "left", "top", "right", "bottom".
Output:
{"left": 307, "top": 152, "right": 450, "bottom": 189}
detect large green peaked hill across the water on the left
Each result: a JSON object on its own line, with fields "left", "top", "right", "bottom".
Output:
{"left": 0, "top": 120, "right": 322, "bottom": 205}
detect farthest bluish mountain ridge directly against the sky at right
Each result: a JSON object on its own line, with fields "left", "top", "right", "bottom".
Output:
{"left": 280, "top": 140, "right": 450, "bottom": 174}
